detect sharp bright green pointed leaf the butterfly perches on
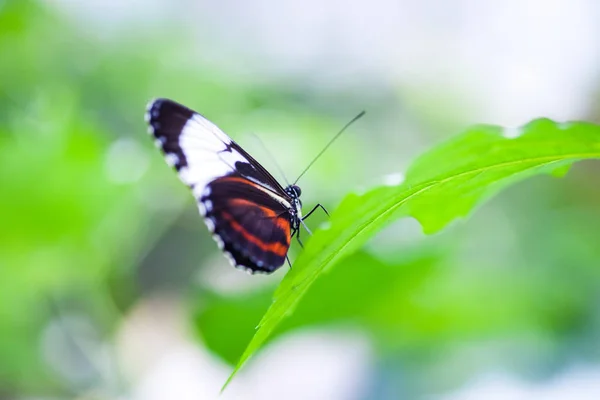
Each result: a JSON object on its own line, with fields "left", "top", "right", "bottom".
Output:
{"left": 223, "top": 119, "right": 600, "bottom": 388}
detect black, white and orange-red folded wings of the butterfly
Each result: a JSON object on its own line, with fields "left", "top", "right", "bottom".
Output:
{"left": 146, "top": 99, "right": 292, "bottom": 273}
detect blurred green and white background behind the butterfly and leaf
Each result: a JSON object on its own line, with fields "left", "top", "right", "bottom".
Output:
{"left": 0, "top": 0, "right": 600, "bottom": 400}
